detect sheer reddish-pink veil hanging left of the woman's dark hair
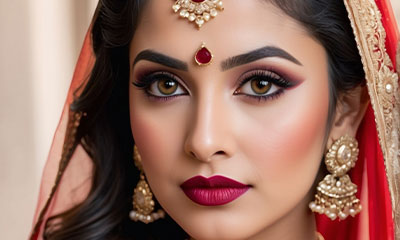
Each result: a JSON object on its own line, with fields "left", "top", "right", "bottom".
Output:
{"left": 31, "top": 24, "right": 95, "bottom": 239}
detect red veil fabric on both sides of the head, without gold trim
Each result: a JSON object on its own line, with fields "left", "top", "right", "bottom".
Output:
{"left": 31, "top": 0, "right": 400, "bottom": 240}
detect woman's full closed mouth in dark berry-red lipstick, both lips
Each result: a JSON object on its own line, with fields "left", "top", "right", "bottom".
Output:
{"left": 181, "top": 176, "right": 250, "bottom": 206}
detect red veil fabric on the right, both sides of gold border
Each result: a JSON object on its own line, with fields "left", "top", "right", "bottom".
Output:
{"left": 317, "top": 0, "right": 400, "bottom": 240}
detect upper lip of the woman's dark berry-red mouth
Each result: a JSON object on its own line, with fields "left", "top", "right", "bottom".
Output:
{"left": 181, "top": 175, "right": 249, "bottom": 189}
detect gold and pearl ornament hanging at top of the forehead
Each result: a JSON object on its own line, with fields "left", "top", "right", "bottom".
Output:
{"left": 172, "top": 0, "right": 224, "bottom": 30}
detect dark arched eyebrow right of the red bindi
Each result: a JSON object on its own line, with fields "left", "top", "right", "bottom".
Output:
{"left": 221, "top": 46, "right": 303, "bottom": 71}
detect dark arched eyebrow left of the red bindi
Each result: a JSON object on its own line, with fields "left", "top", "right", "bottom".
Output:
{"left": 132, "top": 49, "right": 188, "bottom": 71}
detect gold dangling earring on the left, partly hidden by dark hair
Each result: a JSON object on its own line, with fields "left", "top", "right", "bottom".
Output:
{"left": 129, "top": 146, "right": 165, "bottom": 224}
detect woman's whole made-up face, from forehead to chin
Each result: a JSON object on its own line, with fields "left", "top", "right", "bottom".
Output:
{"left": 129, "top": 0, "right": 329, "bottom": 239}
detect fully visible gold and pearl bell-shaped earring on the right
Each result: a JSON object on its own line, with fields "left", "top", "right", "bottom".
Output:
{"left": 309, "top": 135, "right": 361, "bottom": 220}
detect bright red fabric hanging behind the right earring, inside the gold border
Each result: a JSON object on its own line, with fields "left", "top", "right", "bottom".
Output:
{"left": 316, "top": 106, "right": 395, "bottom": 240}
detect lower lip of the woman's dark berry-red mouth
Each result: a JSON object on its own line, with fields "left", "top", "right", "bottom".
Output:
{"left": 183, "top": 187, "right": 249, "bottom": 206}
